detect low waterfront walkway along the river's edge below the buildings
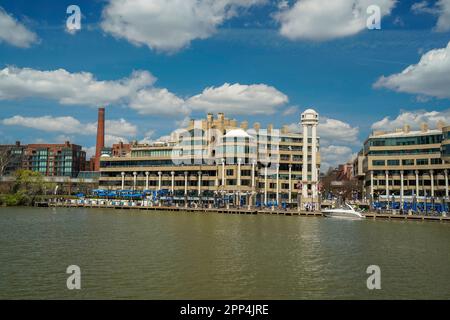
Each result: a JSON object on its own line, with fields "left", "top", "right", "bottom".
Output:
{"left": 48, "top": 202, "right": 450, "bottom": 222}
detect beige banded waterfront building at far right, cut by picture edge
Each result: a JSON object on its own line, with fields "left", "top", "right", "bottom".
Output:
{"left": 353, "top": 123, "right": 450, "bottom": 203}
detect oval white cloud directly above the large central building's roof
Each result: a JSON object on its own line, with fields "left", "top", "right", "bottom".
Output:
{"left": 186, "top": 83, "right": 289, "bottom": 115}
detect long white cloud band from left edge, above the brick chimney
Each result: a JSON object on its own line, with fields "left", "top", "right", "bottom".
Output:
{"left": 0, "top": 67, "right": 185, "bottom": 115}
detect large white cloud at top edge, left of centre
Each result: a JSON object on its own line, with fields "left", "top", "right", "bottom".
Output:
{"left": 101, "top": 0, "right": 266, "bottom": 52}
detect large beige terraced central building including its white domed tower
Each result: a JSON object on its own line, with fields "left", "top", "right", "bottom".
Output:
{"left": 99, "top": 109, "right": 320, "bottom": 205}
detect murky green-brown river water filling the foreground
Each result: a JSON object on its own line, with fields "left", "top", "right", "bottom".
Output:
{"left": 0, "top": 208, "right": 450, "bottom": 299}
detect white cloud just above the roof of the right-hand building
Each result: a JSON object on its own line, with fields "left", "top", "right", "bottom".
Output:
{"left": 372, "top": 109, "right": 450, "bottom": 131}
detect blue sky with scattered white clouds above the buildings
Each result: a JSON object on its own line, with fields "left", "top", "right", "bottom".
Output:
{"left": 0, "top": 0, "right": 450, "bottom": 169}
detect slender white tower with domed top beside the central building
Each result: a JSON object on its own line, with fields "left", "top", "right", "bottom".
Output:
{"left": 301, "top": 109, "right": 319, "bottom": 202}
